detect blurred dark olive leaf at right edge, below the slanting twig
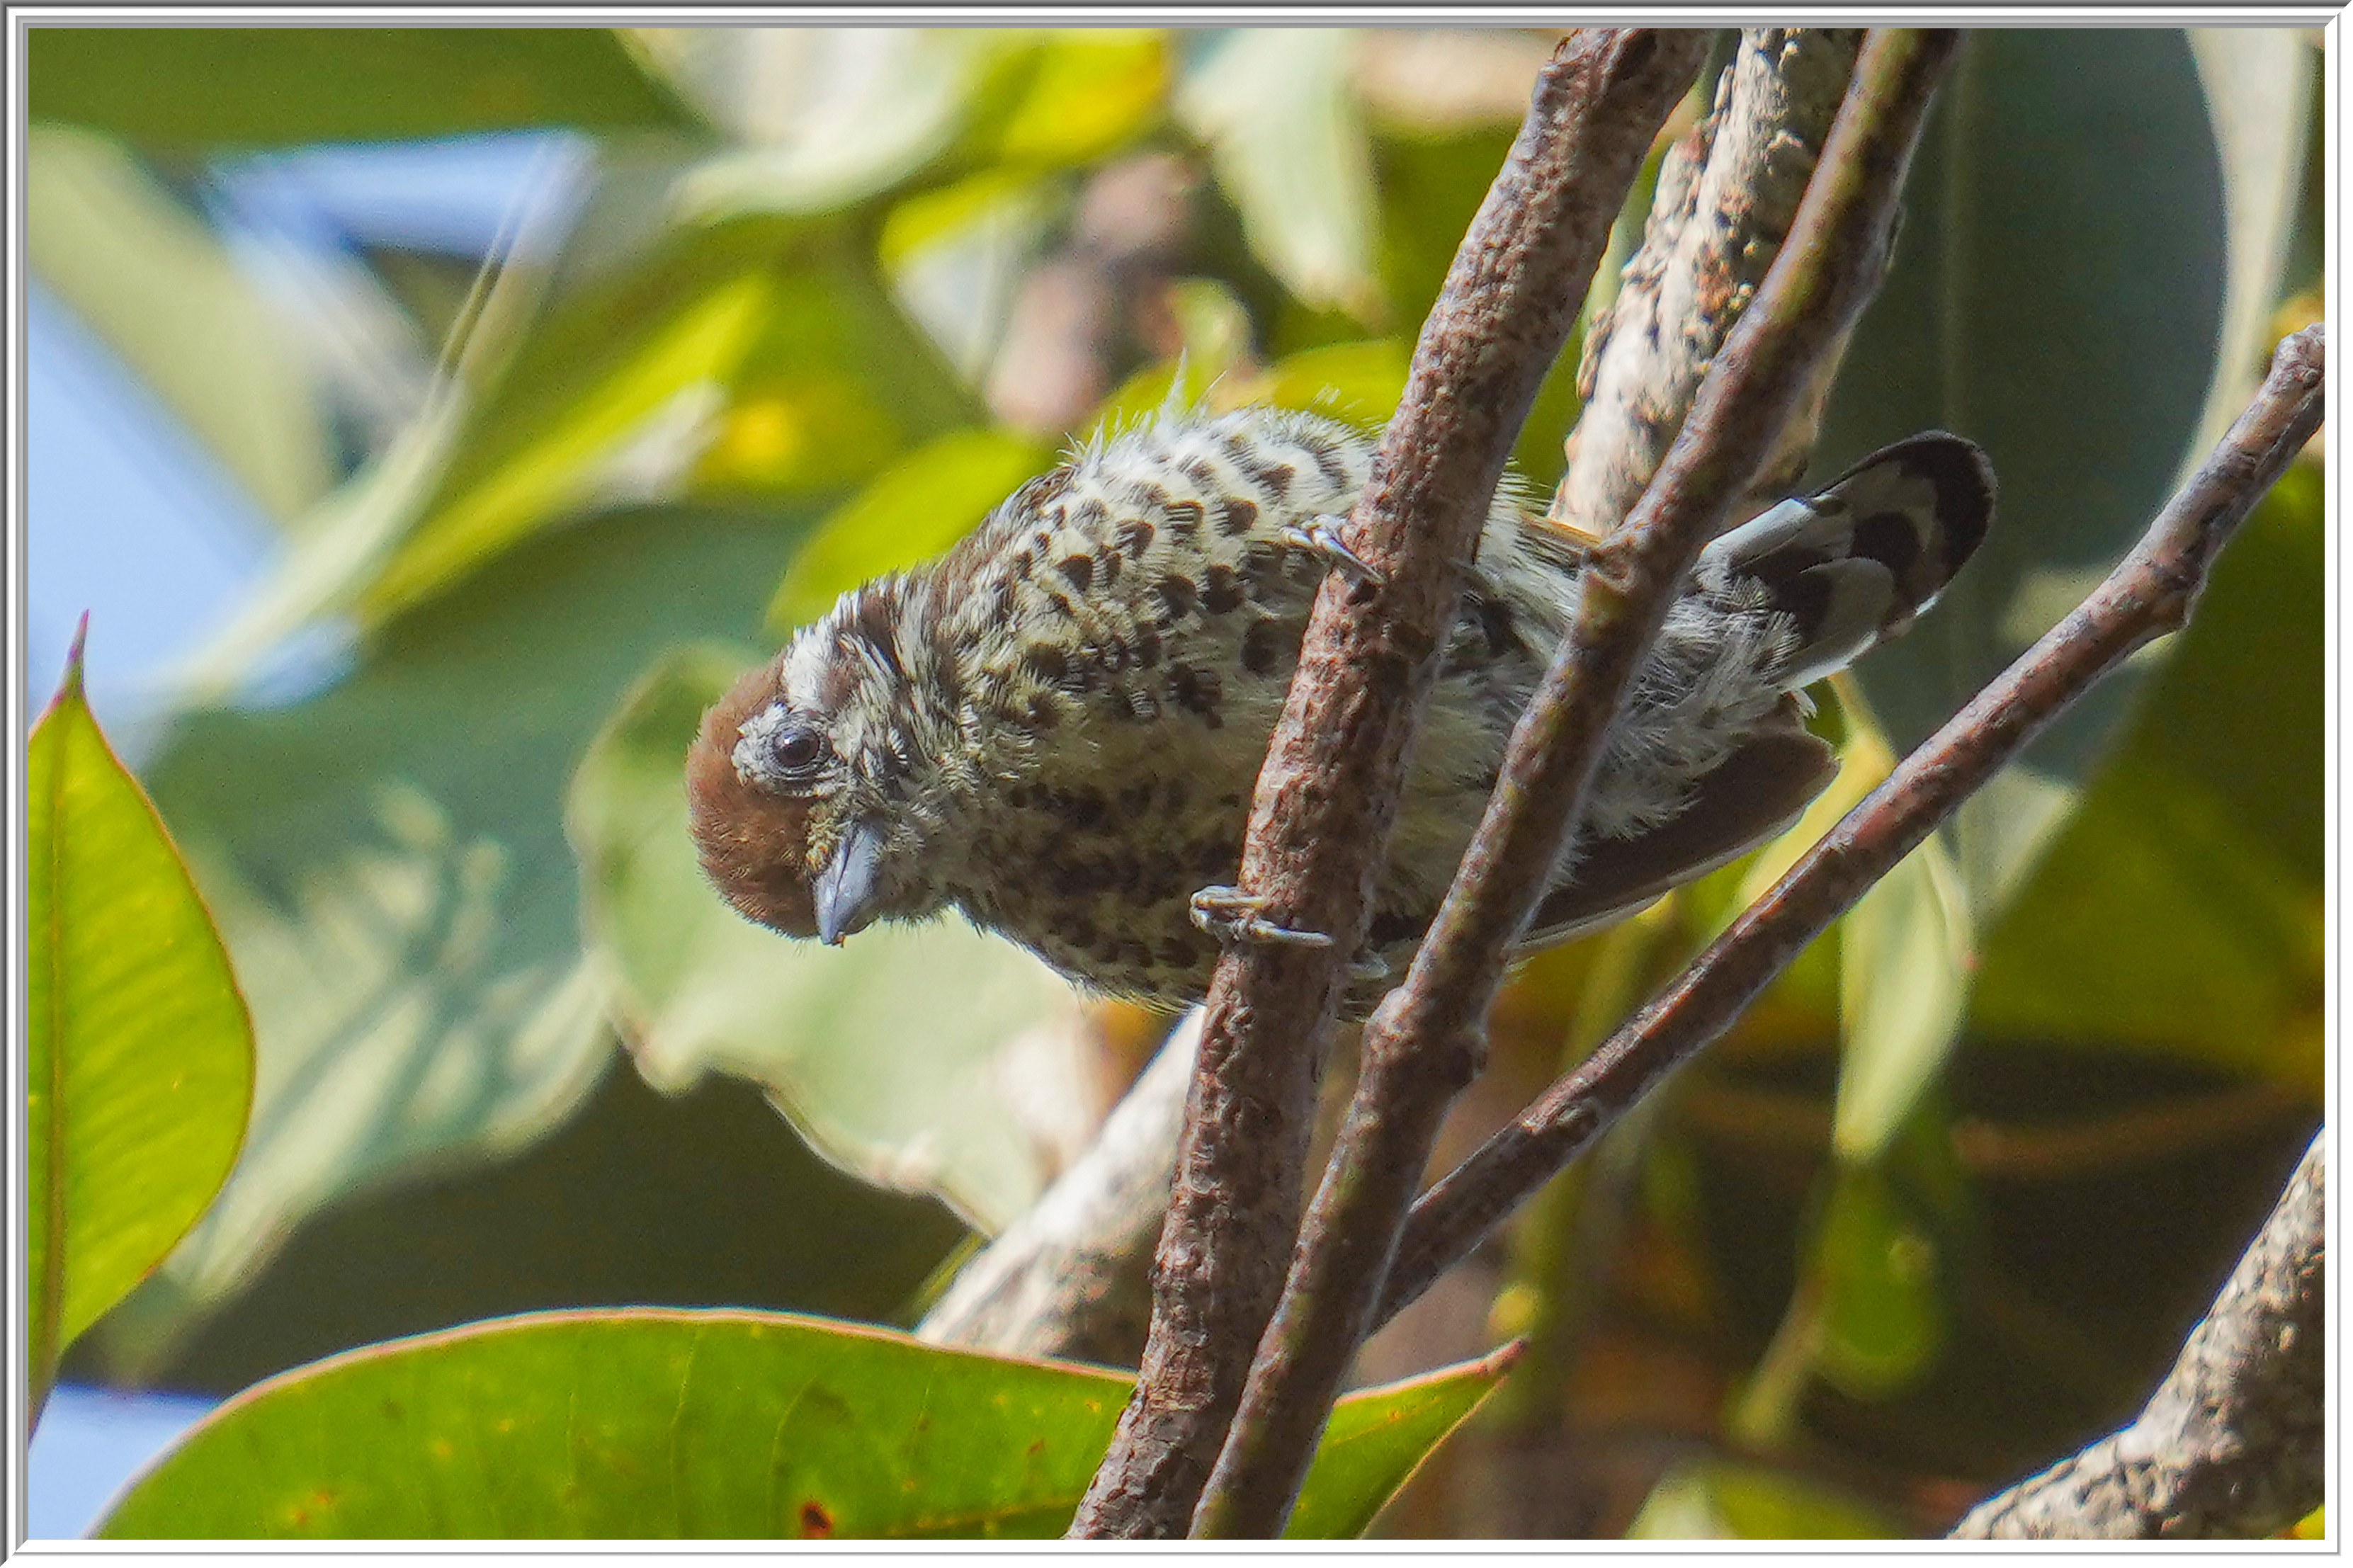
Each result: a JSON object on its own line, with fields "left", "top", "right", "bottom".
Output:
{"left": 1970, "top": 466, "right": 2327, "bottom": 1095}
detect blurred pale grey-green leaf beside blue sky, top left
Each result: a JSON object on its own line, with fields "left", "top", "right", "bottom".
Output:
{"left": 26, "top": 128, "right": 331, "bottom": 521}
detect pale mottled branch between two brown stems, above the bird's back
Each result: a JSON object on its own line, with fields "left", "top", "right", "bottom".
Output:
{"left": 1548, "top": 28, "right": 1864, "bottom": 537}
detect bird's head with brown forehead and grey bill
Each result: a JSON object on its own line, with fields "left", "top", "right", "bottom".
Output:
{"left": 687, "top": 581, "right": 925, "bottom": 944}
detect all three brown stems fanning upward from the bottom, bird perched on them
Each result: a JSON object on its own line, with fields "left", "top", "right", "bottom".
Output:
{"left": 1071, "top": 12, "right": 2325, "bottom": 1538}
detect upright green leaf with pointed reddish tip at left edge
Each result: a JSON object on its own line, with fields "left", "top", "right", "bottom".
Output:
{"left": 26, "top": 636, "right": 254, "bottom": 1413}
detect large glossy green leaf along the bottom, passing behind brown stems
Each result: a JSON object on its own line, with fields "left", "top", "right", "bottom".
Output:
{"left": 101, "top": 1309, "right": 1499, "bottom": 1540}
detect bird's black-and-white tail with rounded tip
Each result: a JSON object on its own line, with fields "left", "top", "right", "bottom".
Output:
{"left": 1694, "top": 431, "right": 1993, "bottom": 690}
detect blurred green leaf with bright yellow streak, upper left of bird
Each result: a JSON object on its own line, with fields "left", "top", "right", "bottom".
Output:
{"left": 344, "top": 195, "right": 970, "bottom": 619}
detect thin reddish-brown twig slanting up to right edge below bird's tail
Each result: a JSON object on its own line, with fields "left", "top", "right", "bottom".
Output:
{"left": 1379, "top": 325, "right": 2327, "bottom": 1321}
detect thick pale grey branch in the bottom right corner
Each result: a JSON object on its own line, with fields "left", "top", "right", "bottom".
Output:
{"left": 1953, "top": 1127, "right": 2327, "bottom": 1540}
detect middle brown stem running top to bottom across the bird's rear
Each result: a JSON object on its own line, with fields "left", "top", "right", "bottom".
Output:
{"left": 1193, "top": 28, "right": 1960, "bottom": 1535}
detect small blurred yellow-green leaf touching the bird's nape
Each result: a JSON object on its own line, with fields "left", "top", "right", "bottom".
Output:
{"left": 767, "top": 431, "right": 1052, "bottom": 633}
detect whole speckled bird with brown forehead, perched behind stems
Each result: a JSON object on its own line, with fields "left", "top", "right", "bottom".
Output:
{"left": 687, "top": 407, "right": 1993, "bottom": 1012}
